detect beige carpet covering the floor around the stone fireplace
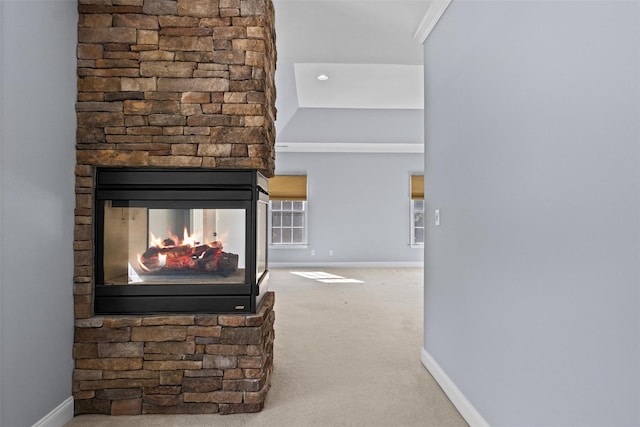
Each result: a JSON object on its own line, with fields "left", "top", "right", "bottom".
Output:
{"left": 67, "top": 268, "right": 467, "bottom": 427}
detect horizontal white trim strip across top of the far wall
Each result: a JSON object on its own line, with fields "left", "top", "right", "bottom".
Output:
{"left": 276, "top": 142, "right": 424, "bottom": 153}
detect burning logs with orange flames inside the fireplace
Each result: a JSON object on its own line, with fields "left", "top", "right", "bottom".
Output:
{"left": 138, "top": 239, "right": 238, "bottom": 273}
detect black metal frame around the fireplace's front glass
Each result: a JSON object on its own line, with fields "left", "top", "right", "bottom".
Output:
{"left": 94, "top": 168, "right": 268, "bottom": 314}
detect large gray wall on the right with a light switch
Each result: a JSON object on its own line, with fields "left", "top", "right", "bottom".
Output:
{"left": 424, "top": 0, "right": 640, "bottom": 427}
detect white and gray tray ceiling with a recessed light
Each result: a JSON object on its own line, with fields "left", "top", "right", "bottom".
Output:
{"left": 273, "top": 0, "right": 432, "bottom": 151}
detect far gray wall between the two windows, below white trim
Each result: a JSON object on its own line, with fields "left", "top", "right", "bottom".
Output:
{"left": 269, "top": 152, "right": 424, "bottom": 265}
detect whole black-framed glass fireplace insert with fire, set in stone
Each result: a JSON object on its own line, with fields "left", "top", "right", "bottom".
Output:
{"left": 94, "top": 168, "right": 268, "bottom": 314}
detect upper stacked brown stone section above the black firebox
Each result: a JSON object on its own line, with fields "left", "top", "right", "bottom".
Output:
{"left": 76, "top": 0, "right": 276, "bottom": 176}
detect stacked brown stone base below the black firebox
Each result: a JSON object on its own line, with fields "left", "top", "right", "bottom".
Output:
{"left": 73, "top": 292, "right": 274, "bottom": 415}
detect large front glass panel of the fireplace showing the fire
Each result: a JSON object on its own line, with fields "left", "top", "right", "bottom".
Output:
{"left": 103, "top": 200, "right": 246, "bottom": 285}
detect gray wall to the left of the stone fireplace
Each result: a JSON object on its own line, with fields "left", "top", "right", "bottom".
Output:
{"left": 0, "top": 0, "right": 78, "bottom": 427}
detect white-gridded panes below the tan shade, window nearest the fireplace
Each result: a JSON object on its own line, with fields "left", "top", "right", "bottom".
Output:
{"left": 269, "top": 200, "right": 307, "bottom": 245}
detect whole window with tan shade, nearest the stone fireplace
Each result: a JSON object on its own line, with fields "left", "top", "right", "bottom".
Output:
{"left": 269, "top": 175, "right": 307, "bottom": 247}
